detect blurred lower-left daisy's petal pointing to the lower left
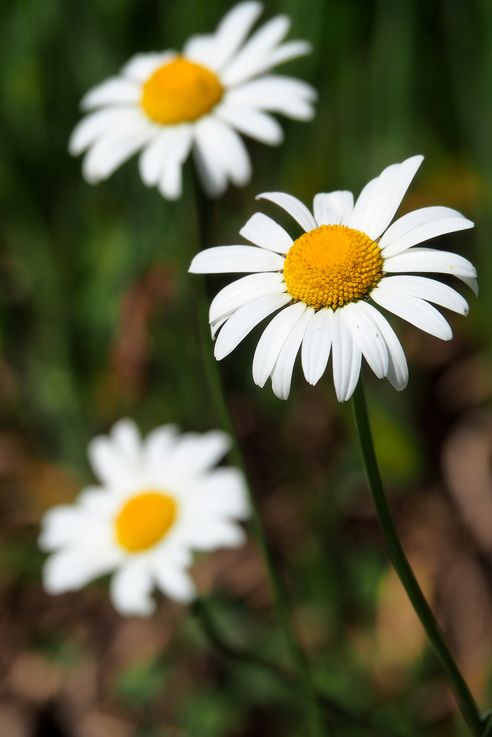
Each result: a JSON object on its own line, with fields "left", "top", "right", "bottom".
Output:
{"left": 43, "top": 545, "right": 119, "bottom": 594}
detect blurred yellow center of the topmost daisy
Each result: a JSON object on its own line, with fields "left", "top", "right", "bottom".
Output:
{"left": 140, "top": 56, "right": 224, "bottom": 125}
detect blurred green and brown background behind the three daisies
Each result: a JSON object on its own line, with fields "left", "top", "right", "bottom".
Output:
{"left": 0, "top": 0, "right": 492, "bottom": 737}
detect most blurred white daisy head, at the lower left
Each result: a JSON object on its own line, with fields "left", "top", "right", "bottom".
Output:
{"left": 39, "top": 420, "right": 248, "bottom": 615}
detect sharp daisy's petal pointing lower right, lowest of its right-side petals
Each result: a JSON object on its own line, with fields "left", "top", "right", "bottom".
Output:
{"left": 371, "top": 279, "right": 453, "bottom": 340}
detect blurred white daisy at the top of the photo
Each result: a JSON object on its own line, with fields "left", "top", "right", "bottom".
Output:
{"left": 69, "top": 2, "right": 315, "bottom": 199}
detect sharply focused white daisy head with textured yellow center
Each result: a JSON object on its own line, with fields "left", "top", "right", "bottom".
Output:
{"left": 190, "top": 156, "right": 477, "bottom": 401}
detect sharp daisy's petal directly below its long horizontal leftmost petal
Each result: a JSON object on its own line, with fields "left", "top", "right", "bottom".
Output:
{"left": 209, "top": 272, "right": 287, "bottom": 323}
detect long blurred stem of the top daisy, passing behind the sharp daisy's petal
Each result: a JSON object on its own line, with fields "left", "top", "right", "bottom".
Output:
{"left": 195, "top": 180, "right": 333, "bottom": 737}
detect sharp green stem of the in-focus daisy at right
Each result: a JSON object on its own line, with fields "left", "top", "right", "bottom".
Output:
{"left": 353, "top": 379, "right": 484, "bottom": 737}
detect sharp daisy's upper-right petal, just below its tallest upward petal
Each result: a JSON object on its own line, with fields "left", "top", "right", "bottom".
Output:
{"left": 379, "top": 207, "right": 474, "bottom": 258}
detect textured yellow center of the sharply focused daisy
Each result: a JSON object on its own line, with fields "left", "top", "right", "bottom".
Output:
{"left": 284, "top": 225, "right": 383, "bottom": 310}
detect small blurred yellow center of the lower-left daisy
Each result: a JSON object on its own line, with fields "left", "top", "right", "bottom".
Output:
{"left": 115, "top": 491, "right": 177, "bottom": 553}
